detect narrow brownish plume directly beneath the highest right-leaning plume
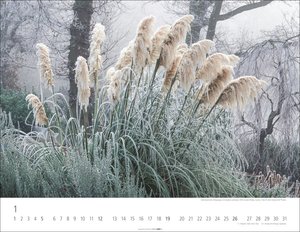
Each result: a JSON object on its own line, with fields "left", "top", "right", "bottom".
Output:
{"left": 161, "top": 43, "right": 188, "bottom": 93}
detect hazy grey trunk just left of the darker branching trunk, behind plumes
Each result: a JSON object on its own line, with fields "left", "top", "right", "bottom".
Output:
{"left": 187, "top": 0, "right": 211, "bottom": 44}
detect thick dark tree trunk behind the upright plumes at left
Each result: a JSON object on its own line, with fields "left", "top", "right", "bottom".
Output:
{"left": 68, "top": 0, "right": 93, "bottom": 115}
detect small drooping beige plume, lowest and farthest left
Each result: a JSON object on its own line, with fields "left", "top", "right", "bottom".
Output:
{"left": 25, "top": 93, "right": 48, "bottom": 126}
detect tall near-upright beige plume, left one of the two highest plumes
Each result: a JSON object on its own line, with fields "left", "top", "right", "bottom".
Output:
{"left": 132, "top": 16, "right": 155, "bottom": 72}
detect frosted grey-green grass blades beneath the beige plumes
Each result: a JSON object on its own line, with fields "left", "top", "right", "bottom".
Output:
{"left": 0, "top": 67, "right": 252, "bottom": 197}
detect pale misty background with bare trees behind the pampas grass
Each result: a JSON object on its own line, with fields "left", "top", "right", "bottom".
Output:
{"left": 1, "top": 0, "right": 300, "bottom": 178}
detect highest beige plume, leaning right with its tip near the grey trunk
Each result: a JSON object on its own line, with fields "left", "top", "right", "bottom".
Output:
{"left": 160, "top": 15, "right": 194, "bottom": 70}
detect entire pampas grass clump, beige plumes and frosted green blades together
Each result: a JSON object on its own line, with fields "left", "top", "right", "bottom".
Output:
{"left": 0, "top": 15, "right": 272, "bottom": 197}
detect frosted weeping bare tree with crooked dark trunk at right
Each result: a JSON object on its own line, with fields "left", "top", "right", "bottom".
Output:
{"left": 237, "top": 29, "right": 300, "bottom": 177}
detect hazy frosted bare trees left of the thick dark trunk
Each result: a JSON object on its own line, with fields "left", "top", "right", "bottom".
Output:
{"left": 1, "top": 1, "right": 72, "bottom": 88}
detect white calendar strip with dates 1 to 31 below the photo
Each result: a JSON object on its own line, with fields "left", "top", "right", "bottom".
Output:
{"left": 1, "top": 198, "right": 300, "bottom": 232}
